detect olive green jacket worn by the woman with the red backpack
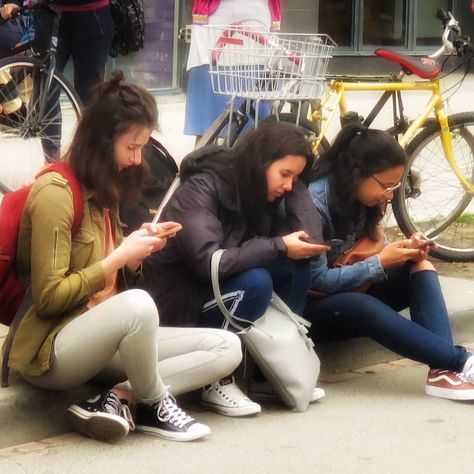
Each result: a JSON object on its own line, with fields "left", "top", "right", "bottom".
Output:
{"left": 3, "top": 172, "right": 133, "bottom": 375}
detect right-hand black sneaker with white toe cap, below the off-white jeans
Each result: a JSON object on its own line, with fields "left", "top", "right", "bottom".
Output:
{"left": 135, "top": 393, "right": 211, "bottom": 441}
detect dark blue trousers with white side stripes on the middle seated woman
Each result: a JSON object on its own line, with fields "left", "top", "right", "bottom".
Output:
{"left": 199, "top": 258, "right": 310, "bottom": 328}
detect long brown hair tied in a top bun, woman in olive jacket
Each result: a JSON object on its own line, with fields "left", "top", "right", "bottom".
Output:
{"left": 65, "top": 71, "right": 158, "bottom": 208}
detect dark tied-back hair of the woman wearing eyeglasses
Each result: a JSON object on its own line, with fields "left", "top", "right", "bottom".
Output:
{"left": 312, "top": 124, "right": 407, "bottom": 240}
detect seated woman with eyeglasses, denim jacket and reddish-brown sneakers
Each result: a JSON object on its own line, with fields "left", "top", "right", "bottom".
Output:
{"left": 303, "top": 124, "right": 474, "bottom": 400}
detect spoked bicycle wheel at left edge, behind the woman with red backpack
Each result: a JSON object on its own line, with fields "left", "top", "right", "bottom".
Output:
{"left": 0, "top": 58, "right": 81, "bottom": 192}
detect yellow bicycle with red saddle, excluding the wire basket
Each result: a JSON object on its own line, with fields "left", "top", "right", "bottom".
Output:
{"left": 304, "top": 11, "right": 474, "bottom": 261}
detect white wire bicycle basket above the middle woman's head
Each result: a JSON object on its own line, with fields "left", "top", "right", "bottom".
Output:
{"left": 207, "top": 23, "right": 336, "bottom": 100}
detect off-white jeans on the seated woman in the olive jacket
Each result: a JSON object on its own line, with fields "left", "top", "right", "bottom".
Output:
{"left": 23, "top": 290, "right": 242, "bottom": 403}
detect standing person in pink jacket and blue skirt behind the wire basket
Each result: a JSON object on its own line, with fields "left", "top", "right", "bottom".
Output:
{"left": 184, "top": 0, "right": 281, "bottom": 140}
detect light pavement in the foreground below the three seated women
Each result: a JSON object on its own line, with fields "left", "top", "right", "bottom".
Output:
{"left": 0, "top": 348, "right": 473, "bottom": 474}
